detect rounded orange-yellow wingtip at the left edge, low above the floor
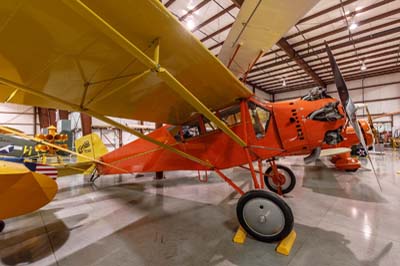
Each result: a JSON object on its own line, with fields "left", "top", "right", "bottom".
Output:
{"left": 0, "top": 161, "right": 58, "bottom": 220}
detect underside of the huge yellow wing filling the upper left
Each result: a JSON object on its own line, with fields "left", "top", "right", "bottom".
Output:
{"left": 0, "top": 0, "right": 251, "bottom": 124}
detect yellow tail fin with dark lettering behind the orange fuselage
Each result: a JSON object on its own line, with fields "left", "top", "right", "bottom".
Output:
{"left": 75, "top": 133, "right": 108, "bottom": 162}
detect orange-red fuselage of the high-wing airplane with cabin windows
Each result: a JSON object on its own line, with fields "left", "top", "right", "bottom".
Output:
{"left": 98, "top": 93, "right": 345, "bottom": 174}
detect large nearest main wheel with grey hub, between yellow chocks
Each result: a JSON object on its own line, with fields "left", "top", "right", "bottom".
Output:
{"left": 236, "top": 190, "right": 294, "bottom": 242}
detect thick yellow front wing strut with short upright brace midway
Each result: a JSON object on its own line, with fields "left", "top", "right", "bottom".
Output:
{"left": 63, "top": 0, "right": 247, "bottom": 147}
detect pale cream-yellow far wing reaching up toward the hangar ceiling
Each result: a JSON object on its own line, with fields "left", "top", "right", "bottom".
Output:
{"left": 218, "top": 0, "right": 319, "bottom": 76}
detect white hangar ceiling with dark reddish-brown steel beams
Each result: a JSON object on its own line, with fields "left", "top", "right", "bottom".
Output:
{"left": 162, "top": 0, "right": 400, "bottom": 94}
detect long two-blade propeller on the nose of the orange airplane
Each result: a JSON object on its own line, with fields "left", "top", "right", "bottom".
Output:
{"left": 325, "top": 43, "right": 382, "bottom": 191}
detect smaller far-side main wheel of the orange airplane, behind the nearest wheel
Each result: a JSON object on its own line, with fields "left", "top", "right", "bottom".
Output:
{"left": 264, "top": 164, "right": 296, "bottom": 194}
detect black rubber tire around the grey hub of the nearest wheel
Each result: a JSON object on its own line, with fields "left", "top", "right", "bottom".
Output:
{"left": 236, "top": 190, "right": 294, "bottom": 243}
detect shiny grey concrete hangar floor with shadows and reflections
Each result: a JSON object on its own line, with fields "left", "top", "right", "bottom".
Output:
{"left": 0, "top": 151, "right": 400, "bottom": 266}
